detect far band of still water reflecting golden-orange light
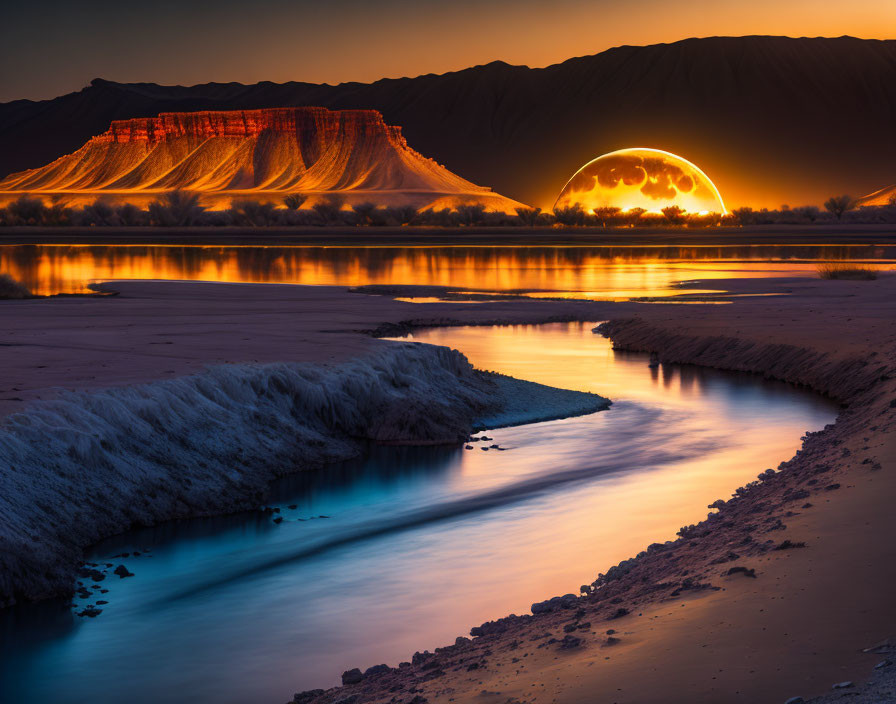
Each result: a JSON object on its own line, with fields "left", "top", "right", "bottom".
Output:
{"left": 0, "top": 245, "right": 896, "bottom": 300}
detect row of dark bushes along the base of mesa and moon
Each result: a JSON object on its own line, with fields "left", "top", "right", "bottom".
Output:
{"left": 0, "top": 191, "right": 896, "bottom": 228}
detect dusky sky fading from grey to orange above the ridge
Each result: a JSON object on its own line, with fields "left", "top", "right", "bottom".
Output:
{"left": 0, "top": 0, "right": 896, "bottom": 102}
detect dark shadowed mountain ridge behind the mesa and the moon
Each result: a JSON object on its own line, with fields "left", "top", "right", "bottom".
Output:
{"left": 0, "top": 37, "right": 896, "bottom": 206}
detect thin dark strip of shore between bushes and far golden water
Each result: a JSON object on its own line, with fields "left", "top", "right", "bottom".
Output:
{"left": 0, "top": 224, "right": 896, "bottom": 247}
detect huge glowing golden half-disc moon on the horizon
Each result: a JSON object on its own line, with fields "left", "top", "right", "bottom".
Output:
{"left": 554, "top": 147, "right": 728, "bottom": 214}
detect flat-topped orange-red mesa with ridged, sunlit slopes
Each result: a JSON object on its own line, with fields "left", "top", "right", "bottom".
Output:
{"left": 0, "top": 107, "right": 520, "bottom": 212}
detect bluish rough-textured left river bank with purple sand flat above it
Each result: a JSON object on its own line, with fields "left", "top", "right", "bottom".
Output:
{"left": 0, "top": 284, "right": 620, "bottom": 605}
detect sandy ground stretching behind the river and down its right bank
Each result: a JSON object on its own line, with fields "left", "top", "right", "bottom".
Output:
{"left": 0, "top": 276, "right": 896, "bottom": 704}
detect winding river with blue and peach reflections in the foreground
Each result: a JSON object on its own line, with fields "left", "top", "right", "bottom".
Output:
{"left": 0, "top": 324, "right": 835, "bottom": 704}
